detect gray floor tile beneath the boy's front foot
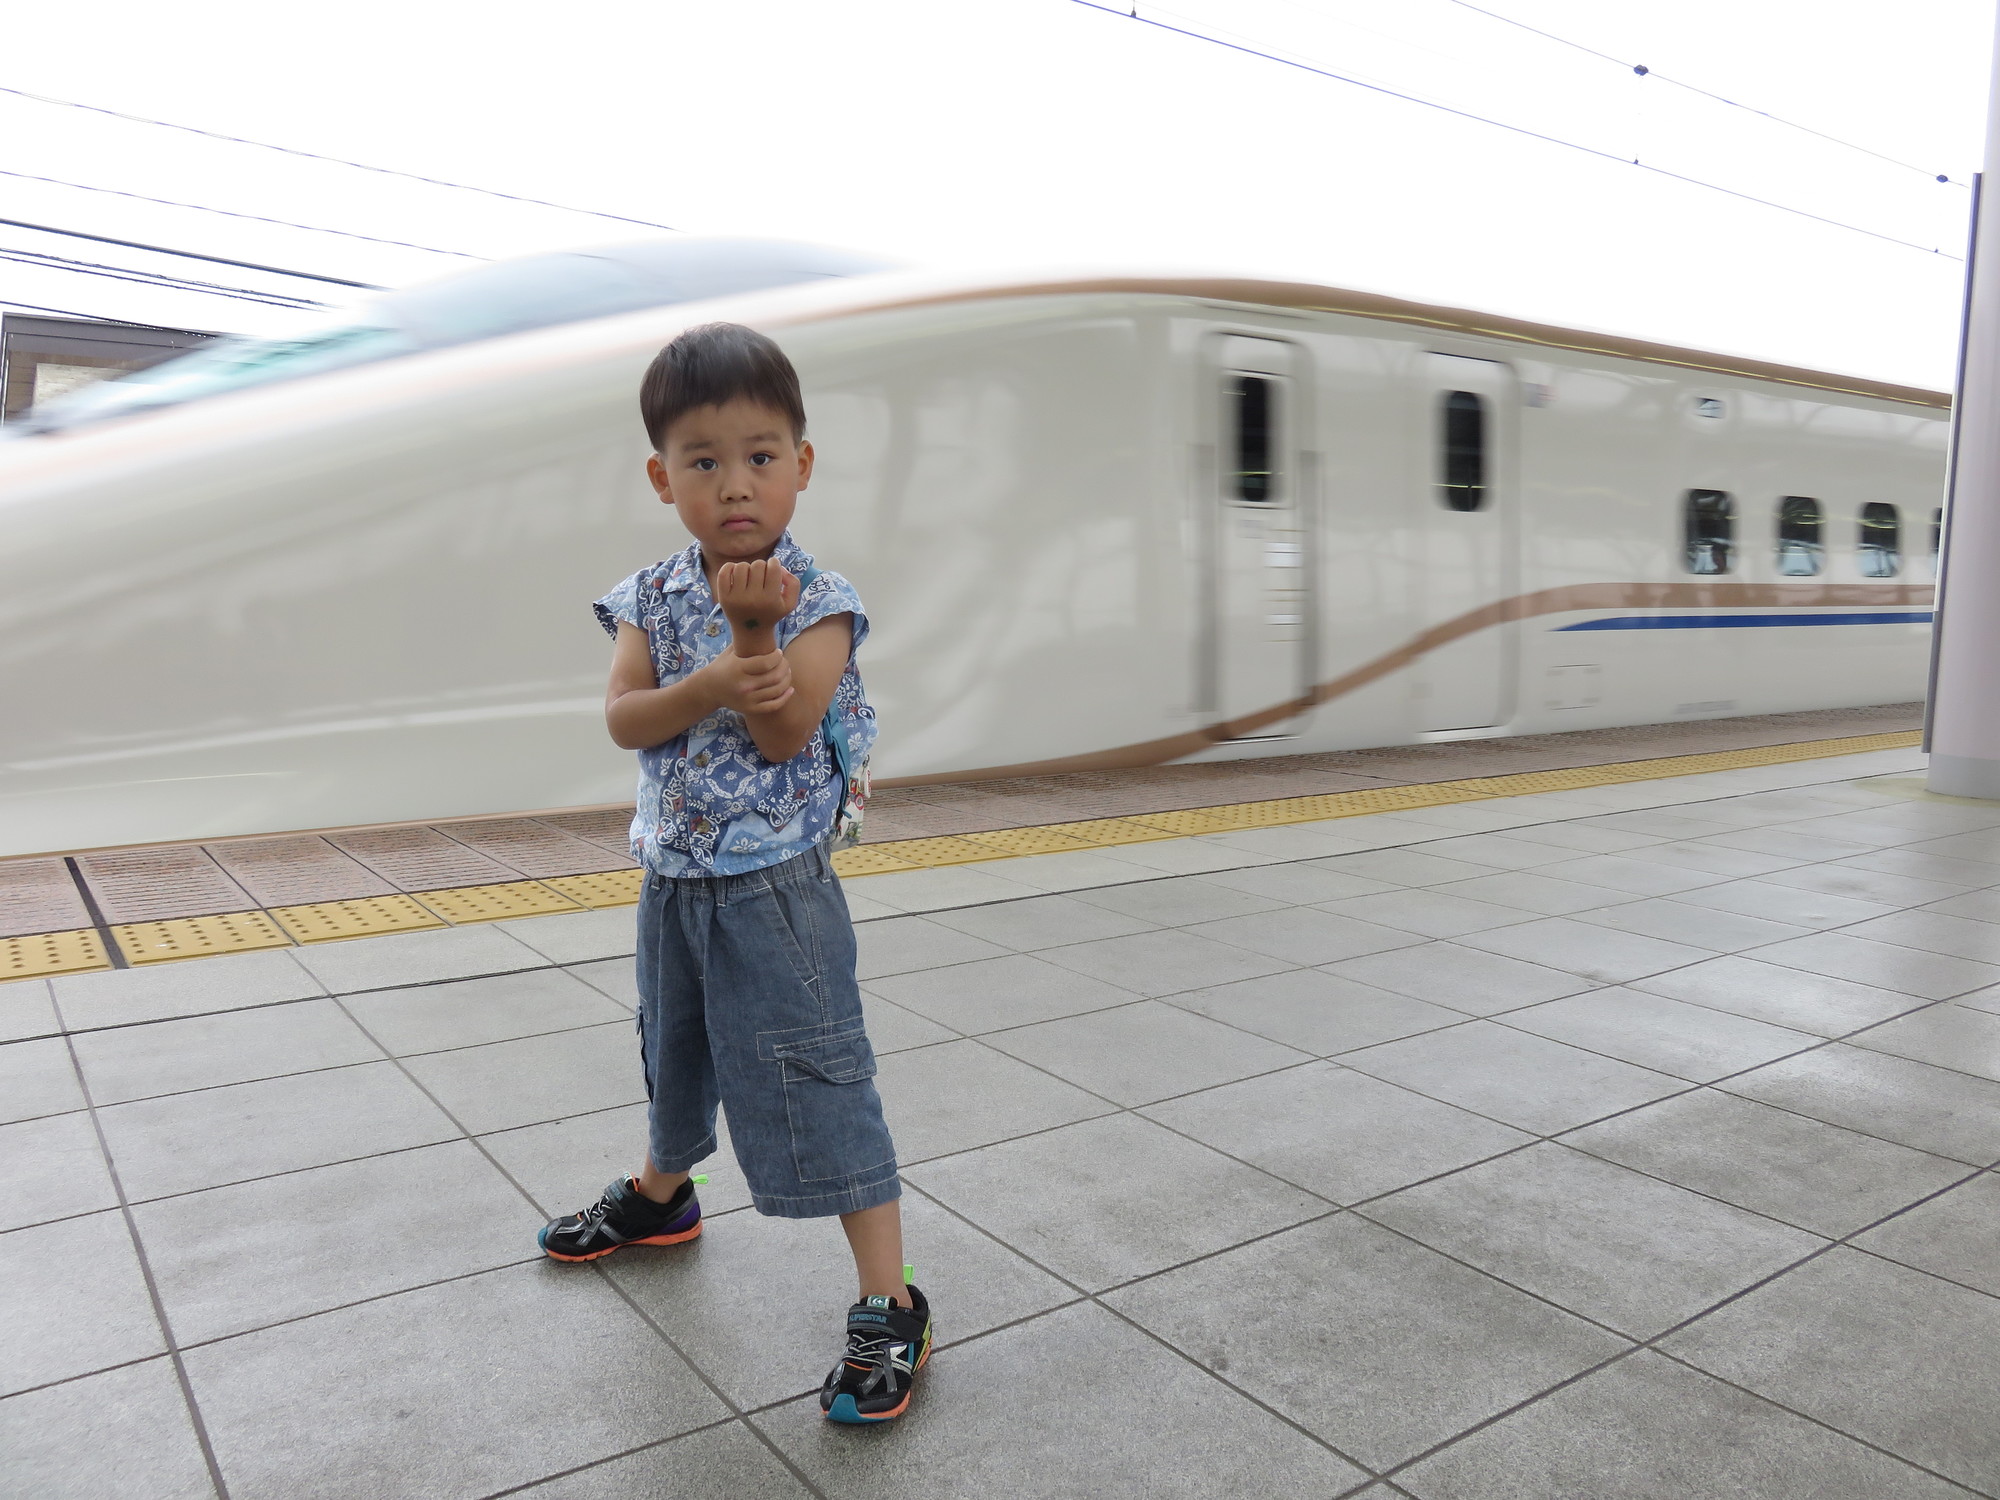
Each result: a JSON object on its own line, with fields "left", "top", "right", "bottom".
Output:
{"left": 608, "top": 1192, "right": 1076, "bottom": 1406}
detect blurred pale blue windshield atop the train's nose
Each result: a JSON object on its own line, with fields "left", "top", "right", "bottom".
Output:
{"left": 8, "top": 238, "right": 892, "bottom": 436}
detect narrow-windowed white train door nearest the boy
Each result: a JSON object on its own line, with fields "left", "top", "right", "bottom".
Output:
{"left": 1206, "top": 334, "right": 1316, "bottom": 740}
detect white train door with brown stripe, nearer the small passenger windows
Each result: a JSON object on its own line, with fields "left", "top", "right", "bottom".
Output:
{"left": 1416, "top": 354, "right": 1520, "bottom": 734}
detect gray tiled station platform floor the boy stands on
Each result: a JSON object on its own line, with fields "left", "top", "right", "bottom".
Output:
{"left": 0, "top": 708, "right": 2000, "bottom": 1500}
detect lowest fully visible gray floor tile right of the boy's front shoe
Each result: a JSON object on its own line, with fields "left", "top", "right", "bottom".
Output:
{"left": 1106, "top": 1214, "right": 1630, "bottom": 1468}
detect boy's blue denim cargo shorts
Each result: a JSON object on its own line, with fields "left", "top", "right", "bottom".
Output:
{"left": 638, "top": 846, "right": 902, "bottom": 1218}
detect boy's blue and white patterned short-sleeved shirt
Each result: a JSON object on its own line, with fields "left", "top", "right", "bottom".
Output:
{"left": 594, "top": 532, "right": 876, "bottom": 880}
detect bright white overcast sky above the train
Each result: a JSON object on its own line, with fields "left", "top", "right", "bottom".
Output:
{"left": 0, "top": 0, "right": 1992, "bottom": 386}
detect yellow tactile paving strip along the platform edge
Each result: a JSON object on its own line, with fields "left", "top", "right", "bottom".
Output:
{"left": 0, "top": 730, "right": 1922, "bottom": 980}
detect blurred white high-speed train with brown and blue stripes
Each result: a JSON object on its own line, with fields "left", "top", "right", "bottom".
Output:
{"left": 0, "top": 242, "right": 1948, "bottom": 854}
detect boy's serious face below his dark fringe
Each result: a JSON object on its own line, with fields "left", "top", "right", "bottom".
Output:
{"left": 646, "top": 398, "right": 812, "bottom": 568}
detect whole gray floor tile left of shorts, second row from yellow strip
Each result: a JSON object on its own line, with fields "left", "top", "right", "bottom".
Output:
{"left": 344, "top": 968, "right": 632, "bottom": 1056}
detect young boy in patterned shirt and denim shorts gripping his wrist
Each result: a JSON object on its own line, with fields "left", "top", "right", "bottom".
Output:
{"left": 540, "top": 324, "right": 930, "bottom": 1422}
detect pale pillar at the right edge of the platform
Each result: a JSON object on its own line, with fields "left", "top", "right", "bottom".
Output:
{"left": 1910, "top": 17, "right": 2000, "bottom": 800}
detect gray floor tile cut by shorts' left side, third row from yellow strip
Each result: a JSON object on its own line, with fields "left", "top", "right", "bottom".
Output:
{"left": 406, "top": 1018, "right": 646, "bottom": 1136}
